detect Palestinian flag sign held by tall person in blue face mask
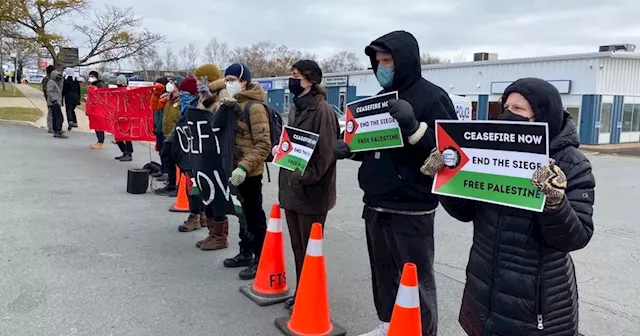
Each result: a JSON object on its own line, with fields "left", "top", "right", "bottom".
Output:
{"left": 344, "top": 91, "right": 404, "bottom": 152}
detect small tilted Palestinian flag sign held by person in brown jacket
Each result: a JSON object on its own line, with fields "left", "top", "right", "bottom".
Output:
{"left": 273, "top": 126, "right": 318, "bottom": 175}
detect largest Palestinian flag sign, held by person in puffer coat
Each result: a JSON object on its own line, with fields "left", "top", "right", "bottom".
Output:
{"left": 432, "top": 120, "right": 549, "bottom": 212}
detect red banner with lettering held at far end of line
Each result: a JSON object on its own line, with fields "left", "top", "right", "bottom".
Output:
{"left": 86, "top": 86, "right": 156, "bottom": 141}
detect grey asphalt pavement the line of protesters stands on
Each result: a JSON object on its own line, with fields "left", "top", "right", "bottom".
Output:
{"left": 0, "top": 124, "right": 640, "bottom": 336}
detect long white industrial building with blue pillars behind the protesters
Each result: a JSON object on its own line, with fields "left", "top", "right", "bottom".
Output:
{"left": 257, "top": 45, "right": 640, "bottom": 144}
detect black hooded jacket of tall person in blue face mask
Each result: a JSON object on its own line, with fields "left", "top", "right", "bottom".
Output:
{"left": 354, "top": 31, "right": 457, "bottom": 211}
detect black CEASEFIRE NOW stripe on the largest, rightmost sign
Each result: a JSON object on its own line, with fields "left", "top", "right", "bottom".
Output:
{"left": 437, "top": 120, "right": 548, "bottom": 154}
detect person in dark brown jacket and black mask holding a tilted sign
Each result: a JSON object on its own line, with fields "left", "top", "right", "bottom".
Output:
{"left": 272, "top": 60, "right": 340, "bottom": 308}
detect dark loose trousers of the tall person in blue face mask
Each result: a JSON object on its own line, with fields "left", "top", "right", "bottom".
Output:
{"left": 362, "top": 205, "right": 438, "bottom": 336}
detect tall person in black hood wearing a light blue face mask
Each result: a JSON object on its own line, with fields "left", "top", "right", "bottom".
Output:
{"left": 334, "top": 31, "right": 457, "bottom": 336}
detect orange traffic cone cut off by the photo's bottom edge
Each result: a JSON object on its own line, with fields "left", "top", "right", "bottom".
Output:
{"left": 387, "top": 263, "right": 422, "bottom": 336}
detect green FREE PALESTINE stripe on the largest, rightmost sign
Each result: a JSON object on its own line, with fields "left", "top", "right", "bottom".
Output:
{"left": 436, "top": 170, "right": 544, "bottom": 211}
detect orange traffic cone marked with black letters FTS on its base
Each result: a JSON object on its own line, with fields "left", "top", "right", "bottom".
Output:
{"left": 240, "top": 203, "right": 291, "bottom": 306}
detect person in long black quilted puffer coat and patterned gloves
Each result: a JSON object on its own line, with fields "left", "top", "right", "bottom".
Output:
{"left": 421, "top": 78, "right": 595, "bottom": 336}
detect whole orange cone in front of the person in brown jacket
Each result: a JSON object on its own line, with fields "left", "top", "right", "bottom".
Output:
{"left": 275, "top": 223, "right": 347, "bottom": 336}
